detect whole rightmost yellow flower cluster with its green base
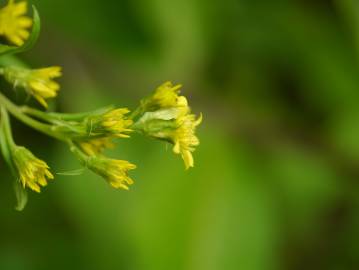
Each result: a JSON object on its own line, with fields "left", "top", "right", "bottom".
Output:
{"left": 134, "top": 82, "right": 202, "bottom": 169}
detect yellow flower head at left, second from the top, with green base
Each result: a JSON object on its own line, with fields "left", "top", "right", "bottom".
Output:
{"left": 2, "top": 66, "right": 62, "bottom": 108}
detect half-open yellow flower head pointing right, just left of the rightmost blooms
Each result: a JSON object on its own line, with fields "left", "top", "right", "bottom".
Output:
{"left": 86, "top": 108, "right": 133, "bottom": 138}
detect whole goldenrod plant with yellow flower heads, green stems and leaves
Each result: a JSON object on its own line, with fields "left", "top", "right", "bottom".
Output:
{"left": 0, "top": 0, "right": 202, "bottom": 210}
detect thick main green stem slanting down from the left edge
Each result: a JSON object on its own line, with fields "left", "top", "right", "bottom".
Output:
{"left": 0, "top": 93, "right": 67, "bottom": 141}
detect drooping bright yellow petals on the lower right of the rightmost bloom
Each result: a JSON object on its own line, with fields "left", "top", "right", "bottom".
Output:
{"left": 170, "top": 113, "right": 202, "bottom": 169}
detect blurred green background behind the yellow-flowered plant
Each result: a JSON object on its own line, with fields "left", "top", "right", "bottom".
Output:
{"left": 0, "top": 0, "right": 359, "bottom": 270}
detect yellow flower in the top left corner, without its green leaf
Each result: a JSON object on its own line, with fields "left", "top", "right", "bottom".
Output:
{"left": 0, "top": 0, "right": 32, "bottom": 46}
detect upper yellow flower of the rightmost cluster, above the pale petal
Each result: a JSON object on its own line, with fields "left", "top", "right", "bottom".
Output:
{"left": 142, "top": 82, "right": 187, "bottom": 111}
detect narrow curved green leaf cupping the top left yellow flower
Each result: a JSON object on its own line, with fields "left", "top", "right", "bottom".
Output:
{"left": 0, "top": 6, "right": 41, "bottom": 56}
